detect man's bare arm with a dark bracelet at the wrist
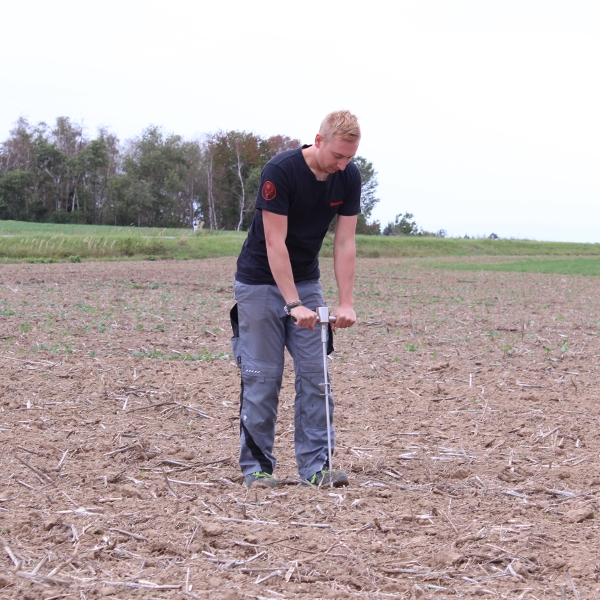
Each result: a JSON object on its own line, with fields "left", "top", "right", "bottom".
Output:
{"left": 262, "top": 210, "right": 317, "bottom": 329}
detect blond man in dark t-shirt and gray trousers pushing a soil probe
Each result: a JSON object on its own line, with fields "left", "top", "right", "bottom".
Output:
{"left": 232, "top": 111, "right": 361, "bottom": 488}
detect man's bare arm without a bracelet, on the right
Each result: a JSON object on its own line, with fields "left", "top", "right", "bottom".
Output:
{"left": 332, "top": 215, "right": 358, "bottom": 328}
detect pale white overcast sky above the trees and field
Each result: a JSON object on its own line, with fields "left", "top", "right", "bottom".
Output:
{"left": 0, "top": 0, "right": 600, "bottom": 242}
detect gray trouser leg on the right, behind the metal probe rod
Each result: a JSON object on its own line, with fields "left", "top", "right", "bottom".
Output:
{"left": 285, "top": 281, "right": 335, "bottom": 479}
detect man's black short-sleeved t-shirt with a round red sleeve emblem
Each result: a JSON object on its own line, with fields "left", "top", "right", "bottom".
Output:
{"left": 235, "top": 146, "right": 361, "bottom": 285}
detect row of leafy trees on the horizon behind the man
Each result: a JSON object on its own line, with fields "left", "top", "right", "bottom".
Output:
{"left": 0, "top": 117, "right": 381, "bottom": 234}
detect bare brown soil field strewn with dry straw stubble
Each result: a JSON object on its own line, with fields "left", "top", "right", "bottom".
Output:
{"left": 0, "top": 259, "right": 600, "bottom": 600}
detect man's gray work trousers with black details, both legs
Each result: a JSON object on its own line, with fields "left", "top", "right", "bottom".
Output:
{"left": 231, "top": 280, "right": 334, "bottom": 479}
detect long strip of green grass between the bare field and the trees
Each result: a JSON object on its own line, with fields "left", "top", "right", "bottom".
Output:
{"left": 0, "top": 221, "right": 600, "bottom": 260}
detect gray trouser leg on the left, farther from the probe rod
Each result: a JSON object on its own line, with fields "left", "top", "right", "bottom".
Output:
{"left": 232, "top": 281, "right": 286, "bottom": 475}
